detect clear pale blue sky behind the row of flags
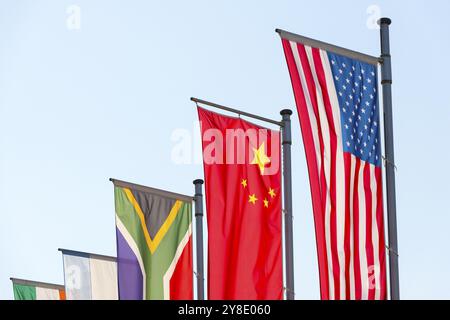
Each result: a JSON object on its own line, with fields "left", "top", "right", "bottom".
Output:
{"left": 0, "top": 0, "right": 450, "bottom": 299}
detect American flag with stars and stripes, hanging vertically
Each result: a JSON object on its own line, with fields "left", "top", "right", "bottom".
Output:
{"left": 282, "top": 38, "right": 386, "bottom": 300}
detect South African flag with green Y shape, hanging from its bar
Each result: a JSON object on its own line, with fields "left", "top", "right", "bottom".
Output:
{"left": 111, "top": 180, "right": 193, "bottom": 300}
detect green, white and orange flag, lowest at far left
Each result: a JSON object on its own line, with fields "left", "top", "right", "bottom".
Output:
{"left": 11, "top": 278, "right": 66, "bottom": 300}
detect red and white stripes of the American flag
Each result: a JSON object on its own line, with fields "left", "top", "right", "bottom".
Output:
{"left": 282, "top": 39, "right": 386, "bottom": 300}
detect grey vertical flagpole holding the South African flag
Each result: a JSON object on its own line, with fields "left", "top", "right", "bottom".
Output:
{"left": 193, "top": 179, "right": 205, "bottom": 300}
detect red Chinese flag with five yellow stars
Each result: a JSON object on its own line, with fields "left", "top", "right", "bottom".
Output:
{"left": 198, "top": 108, "right": 283, "bottom": 300}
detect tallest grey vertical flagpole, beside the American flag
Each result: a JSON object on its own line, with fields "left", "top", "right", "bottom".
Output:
{"left": 378, "top": 18, "right": 400, "bottom": 300}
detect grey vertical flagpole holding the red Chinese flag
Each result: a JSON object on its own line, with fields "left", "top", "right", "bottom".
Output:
{"left": 280, "top": 109, "right": 295, "bottom": 300}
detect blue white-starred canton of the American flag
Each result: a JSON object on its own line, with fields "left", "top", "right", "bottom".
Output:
{"left": 328, "top": 53, "right": 381, "bottom": 167}
